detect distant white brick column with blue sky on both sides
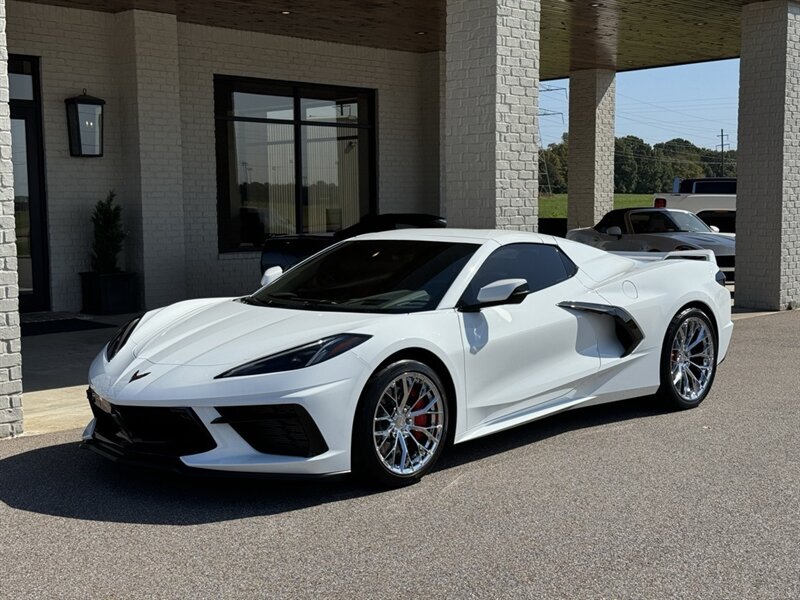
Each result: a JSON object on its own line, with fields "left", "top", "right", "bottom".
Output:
{"left": 567, "top": 69, "right": 616, "bottom": 229}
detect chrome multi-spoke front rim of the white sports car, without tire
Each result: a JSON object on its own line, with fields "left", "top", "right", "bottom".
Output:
{"left": 373, "top": 372, "right": 444, "bottom": 476}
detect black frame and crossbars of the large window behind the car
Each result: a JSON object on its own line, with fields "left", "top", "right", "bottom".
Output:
{"left": 214, "top": 75, "right": 378, "bottom": 254}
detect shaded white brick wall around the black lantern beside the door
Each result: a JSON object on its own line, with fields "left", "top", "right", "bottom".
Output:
{"left": 7, "top": 0, "right": 122, "bottom": 310}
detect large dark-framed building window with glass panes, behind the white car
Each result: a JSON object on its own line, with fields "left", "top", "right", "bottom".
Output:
{"left": 214, "top": 75, "right": 376, "bottom": 252}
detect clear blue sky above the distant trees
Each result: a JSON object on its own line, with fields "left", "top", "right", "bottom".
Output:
{"left": 539, "top": 59, "right": 739, "bottom": 150}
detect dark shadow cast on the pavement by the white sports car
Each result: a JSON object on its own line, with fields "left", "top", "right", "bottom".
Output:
{"left": 0, "top": 397, "right": 663, "bottom": 525}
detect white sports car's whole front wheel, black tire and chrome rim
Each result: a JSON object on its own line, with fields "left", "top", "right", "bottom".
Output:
{"left": 351, "top": 360, "right": 450, "bottom": 487}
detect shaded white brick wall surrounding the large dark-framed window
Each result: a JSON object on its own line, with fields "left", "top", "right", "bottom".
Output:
{"left": 178, "top": 23, "right": 438, "bottom": 296}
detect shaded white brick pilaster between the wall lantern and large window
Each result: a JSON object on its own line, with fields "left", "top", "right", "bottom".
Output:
{"left": 116, "top": 10, "right": 186, "bottom": 308}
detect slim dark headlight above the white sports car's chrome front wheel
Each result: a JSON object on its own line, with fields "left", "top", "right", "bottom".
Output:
{"left": 214, "top": 333, "right": 372, "bottom": 379}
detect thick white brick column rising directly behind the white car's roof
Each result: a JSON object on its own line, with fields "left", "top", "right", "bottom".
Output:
{"left": 444, "top": 0, "right": 540, "bottom": 230}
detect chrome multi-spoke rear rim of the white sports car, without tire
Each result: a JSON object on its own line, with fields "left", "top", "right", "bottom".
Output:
{"left": 670, "top": 317, "right": 716, "bottom": 402}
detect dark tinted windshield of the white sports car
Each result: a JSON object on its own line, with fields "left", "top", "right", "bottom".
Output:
{"left": 250, "top": 240, "right": 479, "bottom": 313}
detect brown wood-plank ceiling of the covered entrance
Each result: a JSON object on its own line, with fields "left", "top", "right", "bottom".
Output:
{"left": 9, "top": 0, "right": 754, "bottom": 79}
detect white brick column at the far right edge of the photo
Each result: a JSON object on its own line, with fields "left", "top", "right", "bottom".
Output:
{"left": 736, "top": 0, "right": 800, "bottom": 310}
